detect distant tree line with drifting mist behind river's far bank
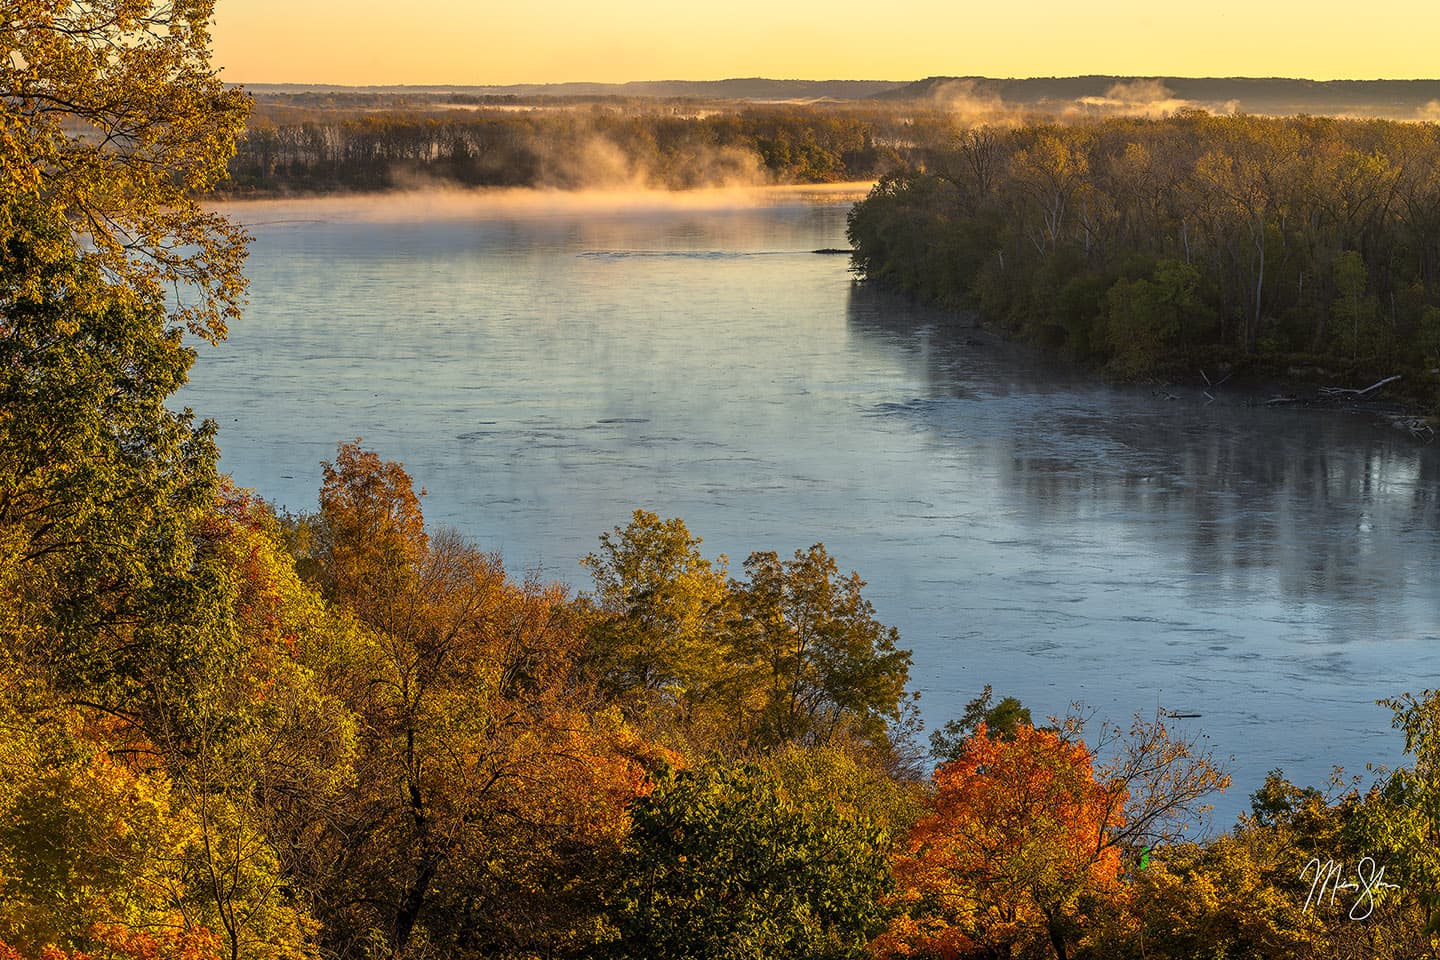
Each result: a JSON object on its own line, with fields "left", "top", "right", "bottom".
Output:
{"left": 225, "top": 104, "right": 937, "bottom": 196}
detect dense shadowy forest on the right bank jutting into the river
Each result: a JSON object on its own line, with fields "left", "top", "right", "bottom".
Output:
{"left": 850, "top": 111, "right": 1440, "bottom": 404}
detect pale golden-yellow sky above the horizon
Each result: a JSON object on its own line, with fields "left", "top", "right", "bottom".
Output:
{"left": 213, "top": 0, "right": 1440, "bottom": 85}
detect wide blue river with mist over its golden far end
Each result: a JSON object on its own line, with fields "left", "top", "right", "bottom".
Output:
{"left": 181, "top": 191, "right": 1440, "bottom": 828}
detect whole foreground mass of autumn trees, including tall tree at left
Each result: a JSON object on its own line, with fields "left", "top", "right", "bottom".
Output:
{"left": 8, "top": 0, "right": 1440, "bottom": 960}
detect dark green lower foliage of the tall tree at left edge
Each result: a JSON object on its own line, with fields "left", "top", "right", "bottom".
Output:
{"left": 0, "top": 198, "right": 232, "bottom": 728}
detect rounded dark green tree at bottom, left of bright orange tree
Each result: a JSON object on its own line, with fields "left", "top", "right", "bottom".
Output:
{"left": 609, "top": 761, "right": 888, "bottom": 960}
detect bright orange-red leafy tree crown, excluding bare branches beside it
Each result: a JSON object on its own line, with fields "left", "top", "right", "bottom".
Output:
{"left": 873, "top": 724, "right": 1125, "bottom": 960}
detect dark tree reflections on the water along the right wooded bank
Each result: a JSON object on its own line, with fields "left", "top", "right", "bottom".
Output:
{"left": 848, "top": 288, "right": 1440, "bottom": 613}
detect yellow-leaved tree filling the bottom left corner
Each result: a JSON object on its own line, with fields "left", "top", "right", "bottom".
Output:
{"left": 0, "top": 687, "right": 300, "bottom": 960}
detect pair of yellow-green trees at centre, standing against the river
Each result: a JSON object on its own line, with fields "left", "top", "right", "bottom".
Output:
{"left": 585, "top": 511, "right": 912, "bottom": 759}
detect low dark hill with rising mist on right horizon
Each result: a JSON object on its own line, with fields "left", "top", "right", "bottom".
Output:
{"left": 876, "top": 76, "right": 1440, "bottom": 119}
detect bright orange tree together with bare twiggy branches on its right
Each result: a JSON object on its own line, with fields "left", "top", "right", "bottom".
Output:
{"left": 877, "top": 713, "right": 1228, "bottom": 960}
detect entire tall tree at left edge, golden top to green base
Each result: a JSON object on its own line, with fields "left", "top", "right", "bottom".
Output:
{"left": 0, "top": 0, "right": 256, "bottom": 782}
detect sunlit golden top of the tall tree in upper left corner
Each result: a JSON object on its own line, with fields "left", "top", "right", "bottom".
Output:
{"left": 0, "top": 0, "right": 248, "bottom": 341}
